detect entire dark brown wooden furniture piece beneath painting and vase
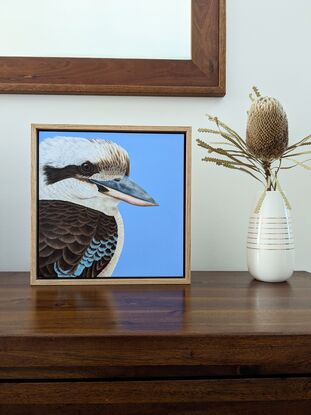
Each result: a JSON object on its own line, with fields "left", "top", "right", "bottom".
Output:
{"left": 0, "top": 272, "right": 311, "bottom": 415}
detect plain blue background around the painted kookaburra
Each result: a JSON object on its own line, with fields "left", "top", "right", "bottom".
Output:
{"left": 39, "top": 131, "right": 184, "bottom": 278}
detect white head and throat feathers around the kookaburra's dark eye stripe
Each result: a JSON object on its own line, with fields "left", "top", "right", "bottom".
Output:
{"left": 39, "top": 136, "right": 129, "bottom": 215}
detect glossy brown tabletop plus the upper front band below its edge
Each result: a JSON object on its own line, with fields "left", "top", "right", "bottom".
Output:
{"left": 0, "top": 272, "right": 311, "bottom": 377}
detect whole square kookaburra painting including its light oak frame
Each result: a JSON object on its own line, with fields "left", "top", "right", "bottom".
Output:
{"left": 31, "top": 125, "right": 191, "bottom": 285}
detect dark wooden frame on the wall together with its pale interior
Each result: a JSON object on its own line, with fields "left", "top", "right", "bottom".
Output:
{"left": 0, "top": 0, "right": 226, "bottom": 96}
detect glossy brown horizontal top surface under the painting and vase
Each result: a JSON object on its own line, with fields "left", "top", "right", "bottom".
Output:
{"left": 0, "top": 272, "right": 311, "bottom": 336}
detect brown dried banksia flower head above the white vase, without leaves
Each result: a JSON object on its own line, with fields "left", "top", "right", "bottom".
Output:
{"left": 246, "top": 95, "right": 288, "bottom": 162}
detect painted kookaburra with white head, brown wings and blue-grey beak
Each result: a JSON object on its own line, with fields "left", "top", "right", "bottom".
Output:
{"left": 38, "top": 137, "right": 157, "bottom": 278}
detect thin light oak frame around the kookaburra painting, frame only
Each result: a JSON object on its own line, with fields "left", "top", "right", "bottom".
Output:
{"left": 30, "top": 124, "right": 191, "bottom": 285}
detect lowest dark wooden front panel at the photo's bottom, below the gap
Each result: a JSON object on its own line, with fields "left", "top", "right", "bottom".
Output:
{"left": 0, "top": 378, "right": 311, "bottom": 415}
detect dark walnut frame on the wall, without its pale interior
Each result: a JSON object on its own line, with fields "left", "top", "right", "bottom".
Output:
{"left": 0, "top": 0, "right": 225, "bottom": 96}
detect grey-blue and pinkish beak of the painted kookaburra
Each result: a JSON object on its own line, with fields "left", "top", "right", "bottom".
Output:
{"left": 89, "top": 176, "right": 158, "bottom": 206}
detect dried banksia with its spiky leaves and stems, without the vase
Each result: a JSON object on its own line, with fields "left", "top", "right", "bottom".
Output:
{"left": 197, "top": 87, "right": 311, "bottom": 209}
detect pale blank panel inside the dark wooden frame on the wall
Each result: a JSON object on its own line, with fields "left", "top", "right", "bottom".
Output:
{"left": 0, "top": 0, "right": 191, "bottom": 59}
